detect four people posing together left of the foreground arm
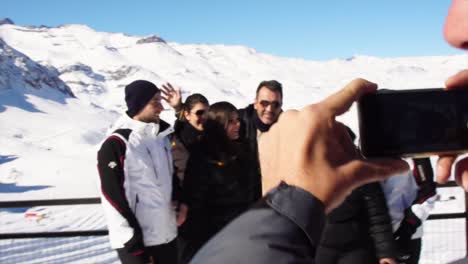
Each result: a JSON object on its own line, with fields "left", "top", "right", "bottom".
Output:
{"left": 98, "top": 80, "right": 282, "bottom": 263}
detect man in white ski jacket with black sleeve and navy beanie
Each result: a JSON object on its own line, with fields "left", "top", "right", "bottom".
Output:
{"left": 98, "top": 80, "right": 185, "bottom": 263}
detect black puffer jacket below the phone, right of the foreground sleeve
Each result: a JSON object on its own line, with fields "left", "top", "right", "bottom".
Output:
{"left": 316, "top": 183, "right": 396, "bottom": 264}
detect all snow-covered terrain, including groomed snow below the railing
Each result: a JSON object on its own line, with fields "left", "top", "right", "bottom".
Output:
{"left": 0, "top": 21, "right": 468, "bottom": 263}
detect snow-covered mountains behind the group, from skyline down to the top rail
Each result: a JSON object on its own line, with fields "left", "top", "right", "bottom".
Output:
{"left": 0, "top": 21, "right": 468, "bottom": 199}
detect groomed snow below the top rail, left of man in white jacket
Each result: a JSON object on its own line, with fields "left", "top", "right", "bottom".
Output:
{"left": 0, "top": 198, "right": 120, "bottom": 264}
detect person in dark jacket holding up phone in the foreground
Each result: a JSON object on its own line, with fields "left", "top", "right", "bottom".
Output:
{"left": 192, "top": 0, "right": 468, "bottom": 264}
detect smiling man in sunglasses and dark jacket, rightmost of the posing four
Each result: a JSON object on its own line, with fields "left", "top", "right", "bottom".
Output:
{"left": 239, "top": 80, "right": 283, "bottom": 201}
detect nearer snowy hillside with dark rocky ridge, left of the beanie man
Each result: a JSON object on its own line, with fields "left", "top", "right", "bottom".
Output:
{"left": 0, "top": 28, "right": 115, "bottom": 200}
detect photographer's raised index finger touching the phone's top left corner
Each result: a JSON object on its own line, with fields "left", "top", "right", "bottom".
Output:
{"left": 320, "top": 79, "right": 377, "bottom": 116}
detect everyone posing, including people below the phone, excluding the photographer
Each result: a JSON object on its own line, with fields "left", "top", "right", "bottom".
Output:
{"left": 98, "top": 80, "right": 436, "bottom": 264}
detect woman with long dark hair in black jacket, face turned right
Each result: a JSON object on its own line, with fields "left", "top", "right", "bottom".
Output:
{"left": 180, "top": 102, "right": 255, "bottom": 263}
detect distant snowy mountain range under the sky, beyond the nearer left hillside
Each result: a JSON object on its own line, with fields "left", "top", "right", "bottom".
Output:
{"left": 0, "top": 25, "right": 468, "bottom": 108}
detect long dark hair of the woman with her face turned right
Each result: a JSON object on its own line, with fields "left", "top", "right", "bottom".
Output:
{"left": 203, "top": 102, "right": 237, "bottom": 157}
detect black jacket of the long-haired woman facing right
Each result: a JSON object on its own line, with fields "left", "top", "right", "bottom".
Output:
{"left": 180, "top": 141, "right": 256, "bottom": 259}
